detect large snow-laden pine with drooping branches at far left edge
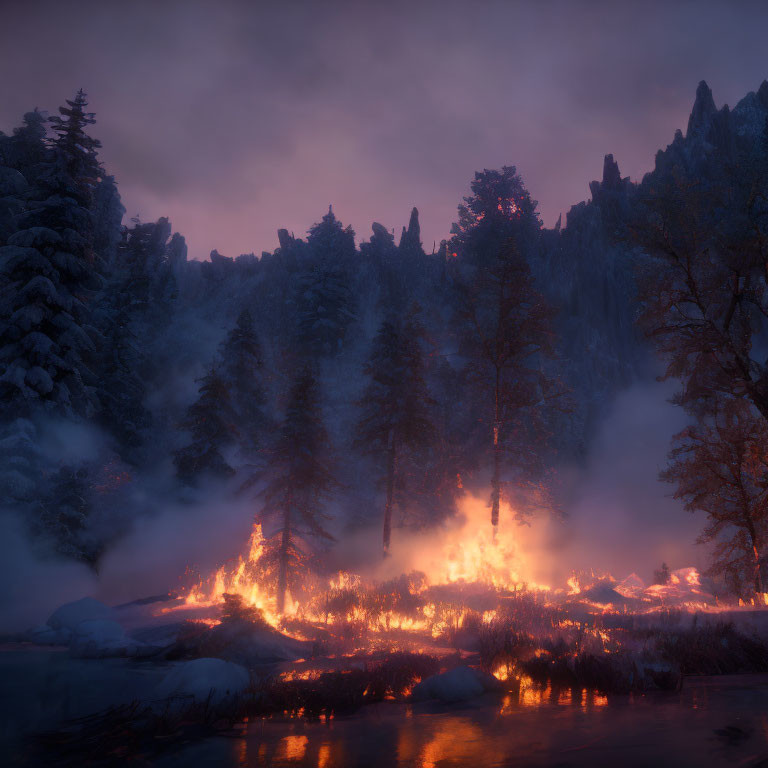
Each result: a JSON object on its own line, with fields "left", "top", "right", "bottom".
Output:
{"left": 0, "top": 91, "right": 101, "bottom": 424}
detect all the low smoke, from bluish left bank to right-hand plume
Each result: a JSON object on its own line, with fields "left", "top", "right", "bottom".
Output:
{"left": 0, "top": 383, "right": 706, "bottom": 632}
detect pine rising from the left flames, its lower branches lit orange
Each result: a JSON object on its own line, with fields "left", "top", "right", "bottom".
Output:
{"left": 259, "top": 369, "right": 336, "bottom": 613}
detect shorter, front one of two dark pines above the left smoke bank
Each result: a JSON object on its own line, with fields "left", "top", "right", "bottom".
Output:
{"left": 174, "top": 367, "right": 238, "bottom": 485}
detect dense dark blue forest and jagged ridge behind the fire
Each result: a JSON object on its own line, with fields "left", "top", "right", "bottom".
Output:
{"left": 0, "top": 82, "right": 768, "bottom": 610}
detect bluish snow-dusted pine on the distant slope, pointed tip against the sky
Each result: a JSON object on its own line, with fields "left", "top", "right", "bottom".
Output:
{"left": 296, "top": 207, "right": 356, "bottom": 355}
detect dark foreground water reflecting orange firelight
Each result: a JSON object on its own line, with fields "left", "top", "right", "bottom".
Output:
{"left": 162, "top": 676, "right": 768, "bottom": 768}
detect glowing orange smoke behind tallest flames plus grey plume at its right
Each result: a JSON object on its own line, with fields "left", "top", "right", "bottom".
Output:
{"left": 332, "top": 382, "right": 706, "bottom": 588}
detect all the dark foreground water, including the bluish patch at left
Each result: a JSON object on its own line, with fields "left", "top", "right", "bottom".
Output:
{"left": 0, "top": 651, "right": 768, "bottom": 768}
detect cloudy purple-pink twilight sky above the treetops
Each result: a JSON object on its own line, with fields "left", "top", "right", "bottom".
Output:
{"left": 0, "top": 0, "right": 768, "bottom": 258}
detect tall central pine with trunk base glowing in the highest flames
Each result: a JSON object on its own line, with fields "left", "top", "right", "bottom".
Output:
{"left": 450, "top": 167, "right": 564, "bottom": 532}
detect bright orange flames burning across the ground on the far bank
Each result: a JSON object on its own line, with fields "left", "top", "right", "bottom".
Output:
{"left": 164, "top": 494, "right": 736, "bottom": 640}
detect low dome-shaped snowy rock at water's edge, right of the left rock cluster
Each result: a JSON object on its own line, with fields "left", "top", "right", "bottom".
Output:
{"left": 154, "top": 659, "right": 251, "bottom": 702}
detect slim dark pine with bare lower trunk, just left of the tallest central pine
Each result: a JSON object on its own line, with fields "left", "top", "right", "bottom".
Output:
{"left": 355, "top": 312, "right": 435, "bottom": 556}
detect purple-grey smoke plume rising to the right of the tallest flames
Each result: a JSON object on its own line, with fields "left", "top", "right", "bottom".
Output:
{"left": 546, "top": 382, "right": 706, "bottom": 581}
